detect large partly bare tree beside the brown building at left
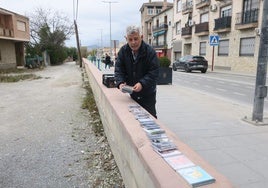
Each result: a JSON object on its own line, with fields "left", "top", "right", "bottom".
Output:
{"left": 26, "top": 8, "right": 74, "bottom": 65}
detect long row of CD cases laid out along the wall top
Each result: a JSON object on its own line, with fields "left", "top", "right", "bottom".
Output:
{"left": 128, "top": 104, "right": 216, "bottom": 187}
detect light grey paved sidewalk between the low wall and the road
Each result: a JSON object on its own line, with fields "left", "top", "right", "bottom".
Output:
{"left": 103, "top": 64, "right": 268, "bottom": 188}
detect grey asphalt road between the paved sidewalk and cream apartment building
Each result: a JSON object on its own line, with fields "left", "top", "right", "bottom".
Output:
{"left": 173, "top": 71, "right": 268, "bottom": 107}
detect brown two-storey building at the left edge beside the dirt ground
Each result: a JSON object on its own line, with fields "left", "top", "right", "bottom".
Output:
{"left": 0, "top": 8, "right": 30, "bottom": 70}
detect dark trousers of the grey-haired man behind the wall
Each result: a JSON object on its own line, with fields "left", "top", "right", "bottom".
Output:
{"left": 131, "top": 92, "right": 157, "bottom": 118}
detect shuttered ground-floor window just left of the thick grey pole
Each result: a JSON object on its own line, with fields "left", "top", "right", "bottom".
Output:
{"left": 239, "top": 37, "right": 255, "bottom": 56}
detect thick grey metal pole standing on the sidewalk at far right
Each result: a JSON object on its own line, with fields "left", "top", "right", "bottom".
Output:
{"left": 252, "top": 0, "right": 268, "bottom": 122}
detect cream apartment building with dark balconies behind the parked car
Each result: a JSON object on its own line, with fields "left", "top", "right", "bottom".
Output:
{"left": 141, "top": 0, "right": 263, "bottom": 73}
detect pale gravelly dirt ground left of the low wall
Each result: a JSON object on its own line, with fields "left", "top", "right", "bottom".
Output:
{"left": 0, "top": 62, "right": 124, "bottom": 188}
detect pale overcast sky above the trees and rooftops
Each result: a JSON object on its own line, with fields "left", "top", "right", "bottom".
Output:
{"left": 0, "top": 0, "right": 172, "bottom": 47}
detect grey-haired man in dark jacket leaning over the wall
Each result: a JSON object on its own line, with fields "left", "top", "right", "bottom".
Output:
{"left": 115, "top": 26, "right": 159, "bottom": 118}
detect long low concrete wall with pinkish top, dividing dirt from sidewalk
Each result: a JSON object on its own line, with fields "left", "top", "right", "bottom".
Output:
{"left": 83, "top": 59, "right": 232, "bottom": 188}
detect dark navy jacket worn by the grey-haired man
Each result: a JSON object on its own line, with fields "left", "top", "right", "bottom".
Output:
{"left": 115, "top": 41, "right": 159, "bottom": 97}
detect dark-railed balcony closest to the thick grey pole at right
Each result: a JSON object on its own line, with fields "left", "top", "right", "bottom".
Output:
{"left": 235, "top": 9, "right": 259, "bottom": 30}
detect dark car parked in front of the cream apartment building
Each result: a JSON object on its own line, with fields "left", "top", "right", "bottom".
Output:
{"left": 172, "top": 55, "right": 208, "bottom": 73}
